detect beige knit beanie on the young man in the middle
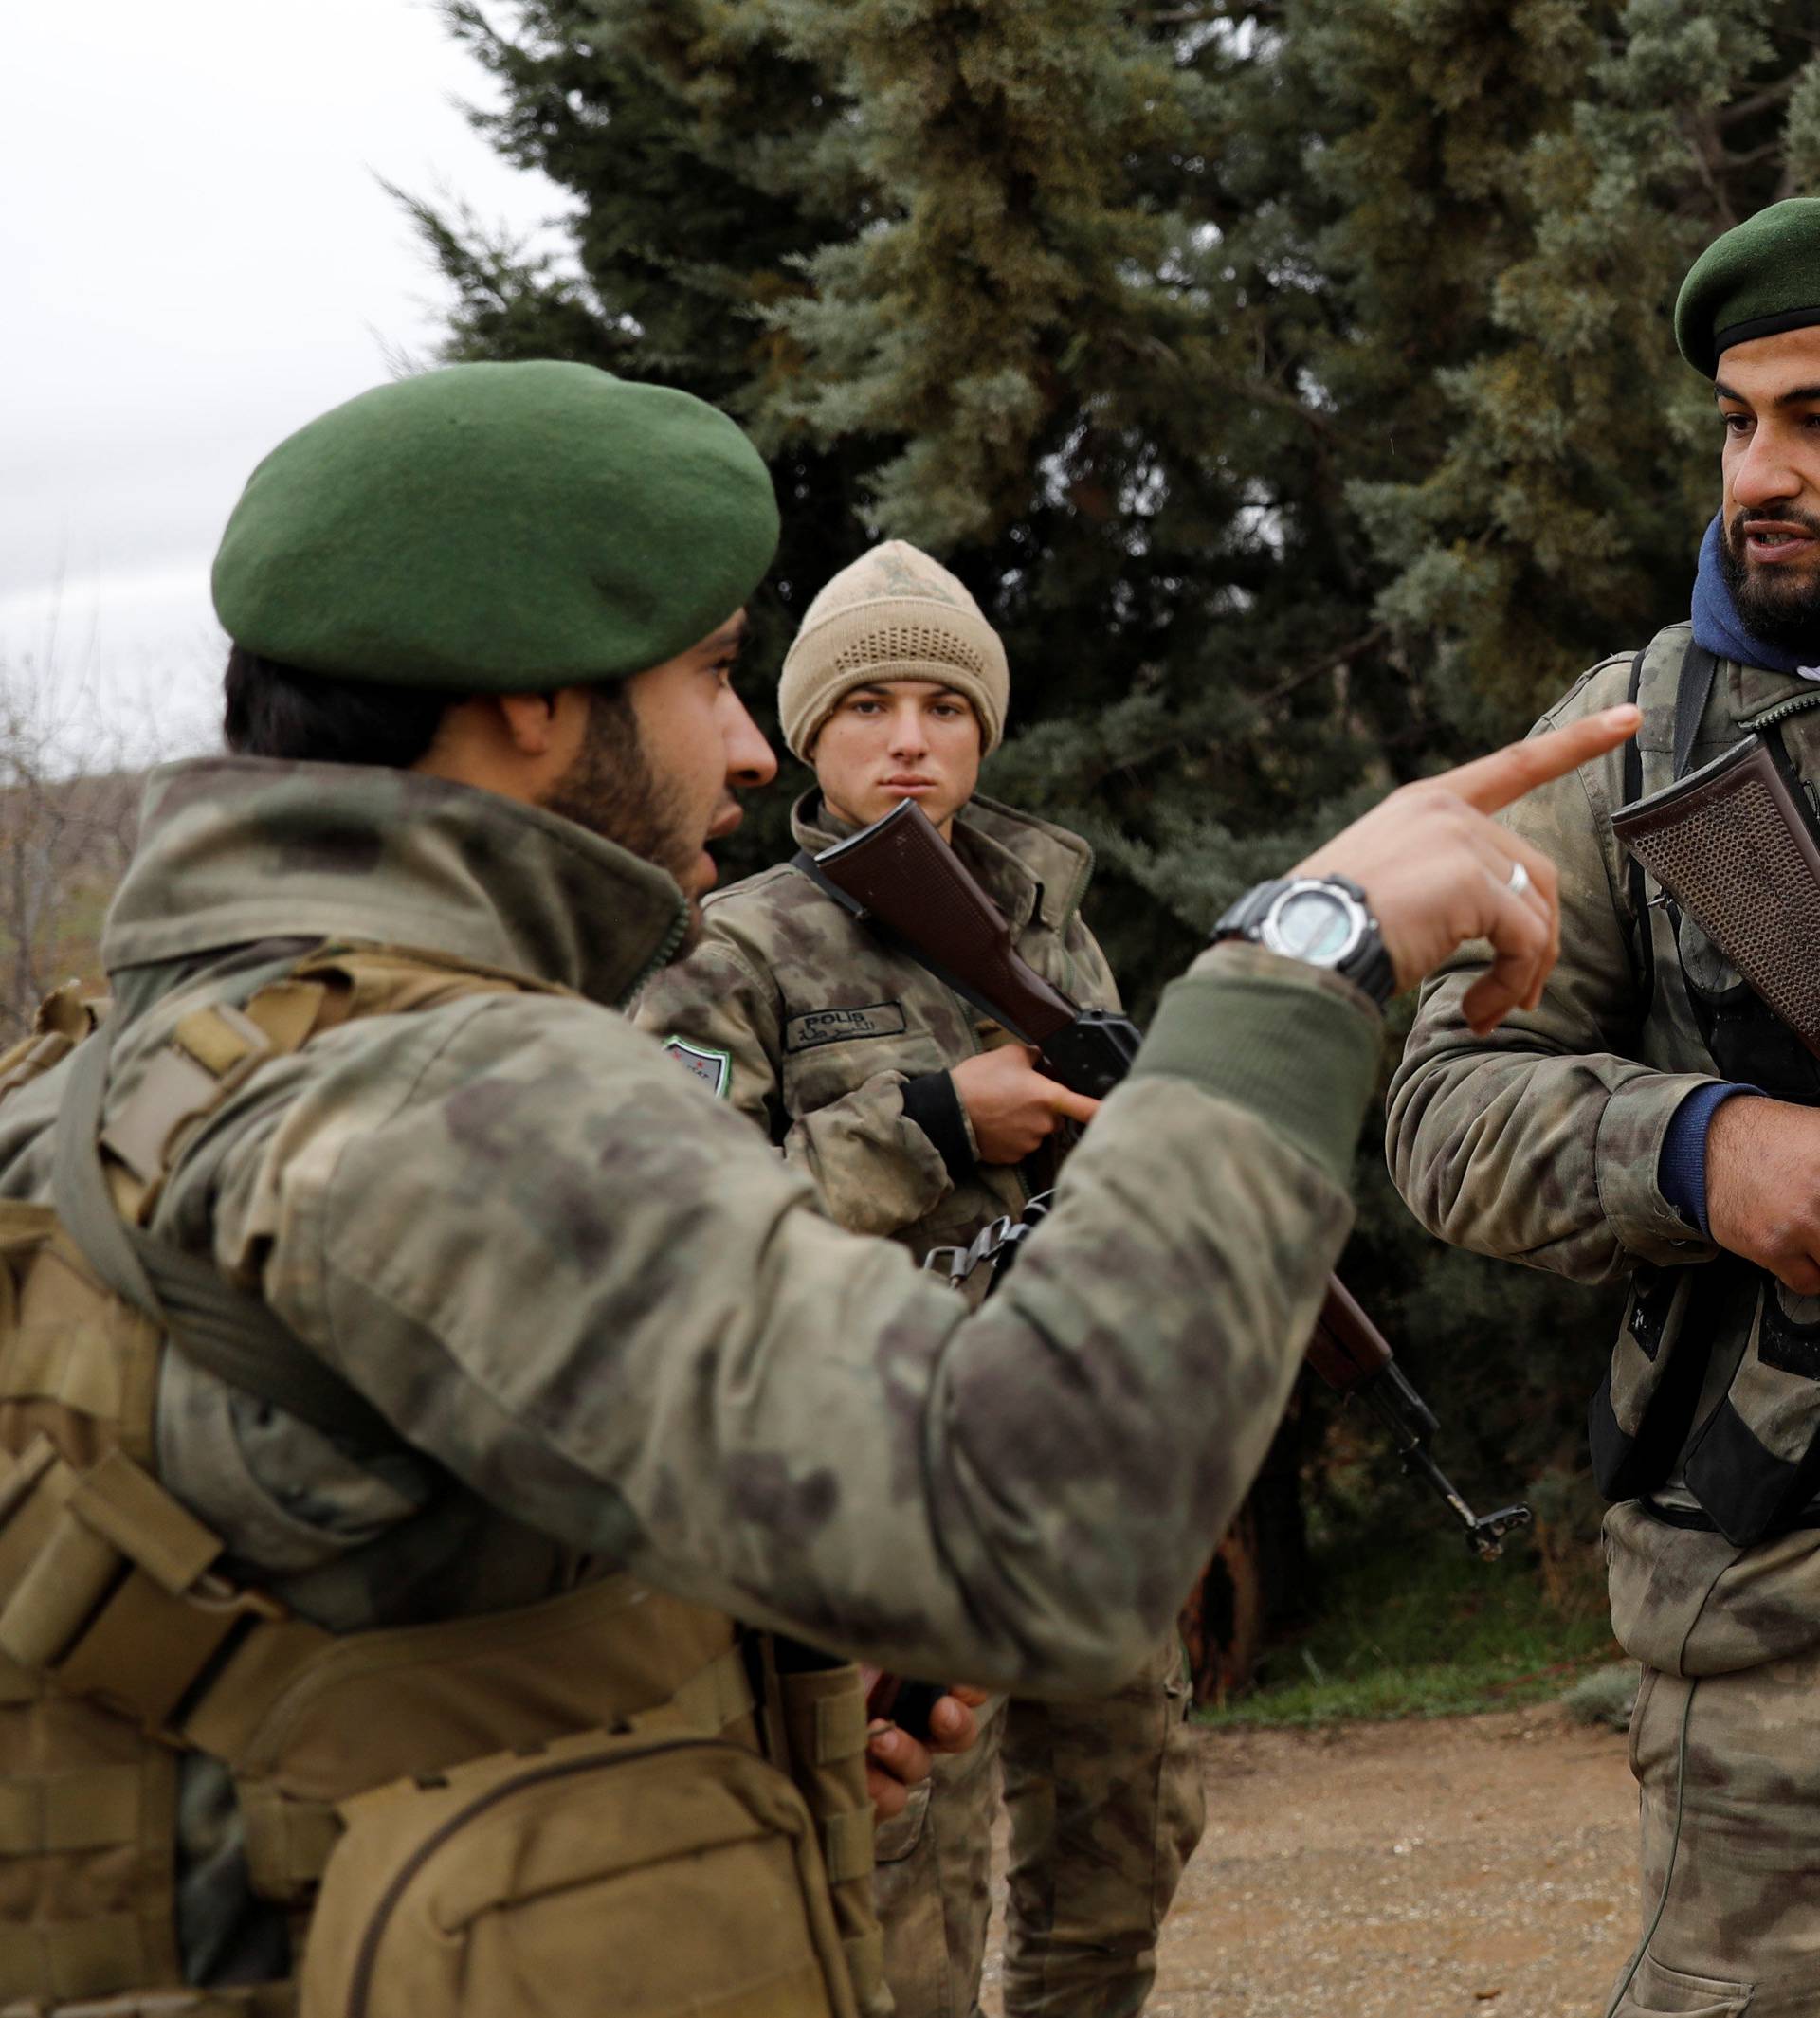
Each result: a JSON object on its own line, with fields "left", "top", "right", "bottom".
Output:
{"left": 777, "top": 538, "right": 1010, "bottom": 763}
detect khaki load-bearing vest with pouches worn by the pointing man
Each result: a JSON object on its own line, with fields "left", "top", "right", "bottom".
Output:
{"left": 0, "top": 944, "right": 890, "bottom": 2018}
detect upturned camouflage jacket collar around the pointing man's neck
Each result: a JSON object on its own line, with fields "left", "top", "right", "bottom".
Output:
{"left": 100, "top": 756, "right": 688, "bottom": 1003}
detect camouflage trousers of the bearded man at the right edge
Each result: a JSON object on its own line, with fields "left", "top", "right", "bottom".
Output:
{"left": 1611, "top": 1651, "right": 1820, "bottom": 2018}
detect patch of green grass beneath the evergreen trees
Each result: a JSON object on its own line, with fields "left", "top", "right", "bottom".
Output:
{"left": 1196, "top": 1536, "right": 1616, "bottom": 1727}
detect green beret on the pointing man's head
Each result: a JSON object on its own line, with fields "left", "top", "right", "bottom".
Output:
{"left": 214, "top": 359, "right": 777, "bottom": 692}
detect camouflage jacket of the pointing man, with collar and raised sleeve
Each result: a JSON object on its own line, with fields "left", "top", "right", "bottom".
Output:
{"left": 0, "top": 759, "right": 1378, "bottom": 1693}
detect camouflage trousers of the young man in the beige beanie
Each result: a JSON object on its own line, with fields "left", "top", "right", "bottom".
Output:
{"left": 874, "top": 1634, "right": 1207, "bottom": 2018}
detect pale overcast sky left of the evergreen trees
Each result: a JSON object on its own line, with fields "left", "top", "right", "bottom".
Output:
{"left": 0, "top": 0, "right": 561, "bottom": 751}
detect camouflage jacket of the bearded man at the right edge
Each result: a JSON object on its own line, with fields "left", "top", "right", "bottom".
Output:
{"left": 1388, "top": 626, "right": 1820, "bottom": 1673}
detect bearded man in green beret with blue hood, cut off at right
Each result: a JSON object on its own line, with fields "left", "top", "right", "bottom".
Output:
{"left": 1391, "top": 198, "right": 1820, "bottom": 2018}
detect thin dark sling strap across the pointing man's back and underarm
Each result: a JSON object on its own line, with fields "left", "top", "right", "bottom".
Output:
{"left": 50, "top": 1023, "right": 402, "bottom": 1453}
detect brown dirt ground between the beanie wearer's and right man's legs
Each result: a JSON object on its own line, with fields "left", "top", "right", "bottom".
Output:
{"left": 985, "top": 1705, "right": 1636, "bottom": 2018}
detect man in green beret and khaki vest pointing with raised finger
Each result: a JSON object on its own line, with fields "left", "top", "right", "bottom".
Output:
{"left": 0, "top": 363, "right": 1634, "bottom": 2018}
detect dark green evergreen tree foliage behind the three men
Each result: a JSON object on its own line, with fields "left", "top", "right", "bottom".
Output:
{"left": 411, "top": 0, "right": 1820, "bottom": 1557}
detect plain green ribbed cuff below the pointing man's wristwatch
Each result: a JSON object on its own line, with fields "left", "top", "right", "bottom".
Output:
{"left": 1132, "top": 944, "right": 1384, "bottom": 1187}
